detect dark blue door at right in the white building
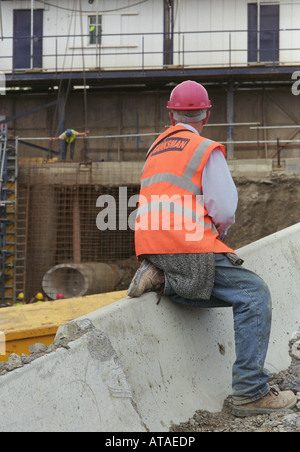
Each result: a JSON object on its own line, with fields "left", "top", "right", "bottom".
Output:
{"left": 248, "top": 3, "right": 279, "bottom": 63}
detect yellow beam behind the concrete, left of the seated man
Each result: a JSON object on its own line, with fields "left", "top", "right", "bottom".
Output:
{"left": 0, "top": 291, "right": 127, "bottom": 362}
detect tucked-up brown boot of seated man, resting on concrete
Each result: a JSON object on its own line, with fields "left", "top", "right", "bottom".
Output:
{"left": 127, "top": 259, "right": 165, "bottom": 298}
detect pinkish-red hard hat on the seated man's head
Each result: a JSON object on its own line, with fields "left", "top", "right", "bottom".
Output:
{"left": 167, "top": 80, "right": 212, "bottom": 110}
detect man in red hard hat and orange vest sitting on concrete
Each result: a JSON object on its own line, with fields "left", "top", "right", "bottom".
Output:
{"left": 128, "top": 80, "right": 297, "bottom": 417}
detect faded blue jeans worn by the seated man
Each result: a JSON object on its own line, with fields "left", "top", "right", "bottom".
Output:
{"left": 164, "top": 254, "right": 272, "bottom": 405}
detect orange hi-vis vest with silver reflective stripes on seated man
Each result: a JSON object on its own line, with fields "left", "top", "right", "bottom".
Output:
{"left": 135, "top": 125, "right": 234, "bottom": 257}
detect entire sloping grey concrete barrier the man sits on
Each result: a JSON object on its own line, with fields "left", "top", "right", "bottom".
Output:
{"left": 0, "top": 224, "right": 300, "bottom": 432}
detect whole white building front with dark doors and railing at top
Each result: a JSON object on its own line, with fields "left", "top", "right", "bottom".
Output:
{"left": 0, "top": 0, "right": 300, "bottom": 73}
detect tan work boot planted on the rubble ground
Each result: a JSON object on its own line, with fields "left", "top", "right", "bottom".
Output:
{"left": 232, "top": 388, "right": 297, "bottom": 417}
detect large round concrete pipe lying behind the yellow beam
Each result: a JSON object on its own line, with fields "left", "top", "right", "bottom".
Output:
{"left": 43, "top": 263, "right": 123, "bottom": 300}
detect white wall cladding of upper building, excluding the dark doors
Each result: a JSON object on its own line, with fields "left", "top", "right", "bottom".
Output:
{"left": 0, "top": 0, "right": 300, "bottom": 72}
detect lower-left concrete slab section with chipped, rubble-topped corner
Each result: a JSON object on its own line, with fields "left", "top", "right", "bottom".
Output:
{"left": 0, "top": 329, "right": 145, "bottom": 432}
